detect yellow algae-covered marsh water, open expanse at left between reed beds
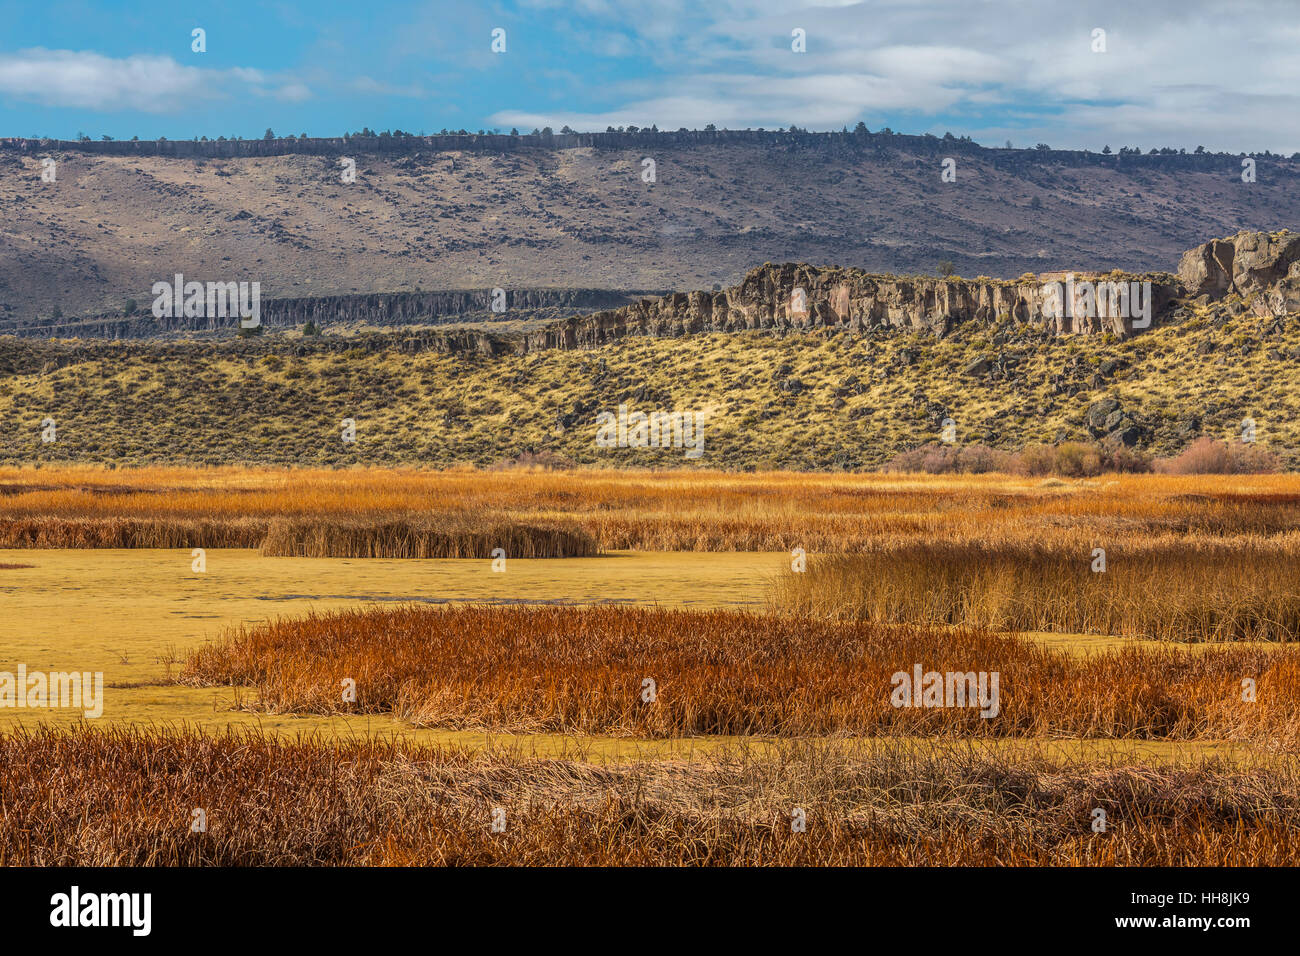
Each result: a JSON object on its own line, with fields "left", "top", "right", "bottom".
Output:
{"left": 0, "top": 549, "right": 789, "bottom": 740}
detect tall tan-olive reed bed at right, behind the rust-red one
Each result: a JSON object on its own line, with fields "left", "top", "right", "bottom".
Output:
{"left": 771, "top": 546, "right": 1300, "bottom": 643}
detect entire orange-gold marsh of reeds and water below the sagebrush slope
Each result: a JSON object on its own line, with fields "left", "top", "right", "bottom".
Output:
{"left": 0, "top": 467, "right": 1300, "bottom": 865}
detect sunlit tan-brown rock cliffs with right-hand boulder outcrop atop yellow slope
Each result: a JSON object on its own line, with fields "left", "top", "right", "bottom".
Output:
{"left": 525, "top": 230, "right": 1300, "bottom": 349}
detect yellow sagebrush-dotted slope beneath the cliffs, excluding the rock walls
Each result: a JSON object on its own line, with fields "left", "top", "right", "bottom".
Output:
{"left": 0, "top": 291, "right": 1300, "bottom": 470}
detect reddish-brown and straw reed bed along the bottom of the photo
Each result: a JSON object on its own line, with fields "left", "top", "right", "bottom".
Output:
{"left": 0, "top": 727, "right": 1300, "bottom": 866}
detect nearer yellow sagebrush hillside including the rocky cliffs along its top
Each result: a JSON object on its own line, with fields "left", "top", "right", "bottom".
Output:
{"left": 0, "top": 230, "right": 1300, "bottom": 470}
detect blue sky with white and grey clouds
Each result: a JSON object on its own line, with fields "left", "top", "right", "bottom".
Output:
{"left": 0, "top": 0, "right": 1300, "bottom": 155}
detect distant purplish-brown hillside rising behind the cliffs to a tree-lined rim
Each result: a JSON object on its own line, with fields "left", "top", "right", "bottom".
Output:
{"left": 0, "top": 133, "right": 1300, "bottom": 330}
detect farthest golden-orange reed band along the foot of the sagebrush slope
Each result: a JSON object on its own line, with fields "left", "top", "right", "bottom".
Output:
{"left": 0, "top": 467, "right": 1300, "bottom": 557}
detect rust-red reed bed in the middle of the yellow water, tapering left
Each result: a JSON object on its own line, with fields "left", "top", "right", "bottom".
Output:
{"left": 176, "top": 606, "right": 1300, "bottom": 749}
